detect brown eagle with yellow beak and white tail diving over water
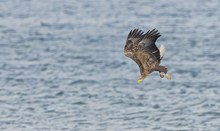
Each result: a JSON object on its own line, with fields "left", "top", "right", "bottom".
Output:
{"left": 124, "top": 28, "right": 171, "bottom": 84}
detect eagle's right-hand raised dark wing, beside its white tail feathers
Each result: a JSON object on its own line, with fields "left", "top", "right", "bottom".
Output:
{"left": 138, "top": 29, "right": 161, "bottom": 62}
